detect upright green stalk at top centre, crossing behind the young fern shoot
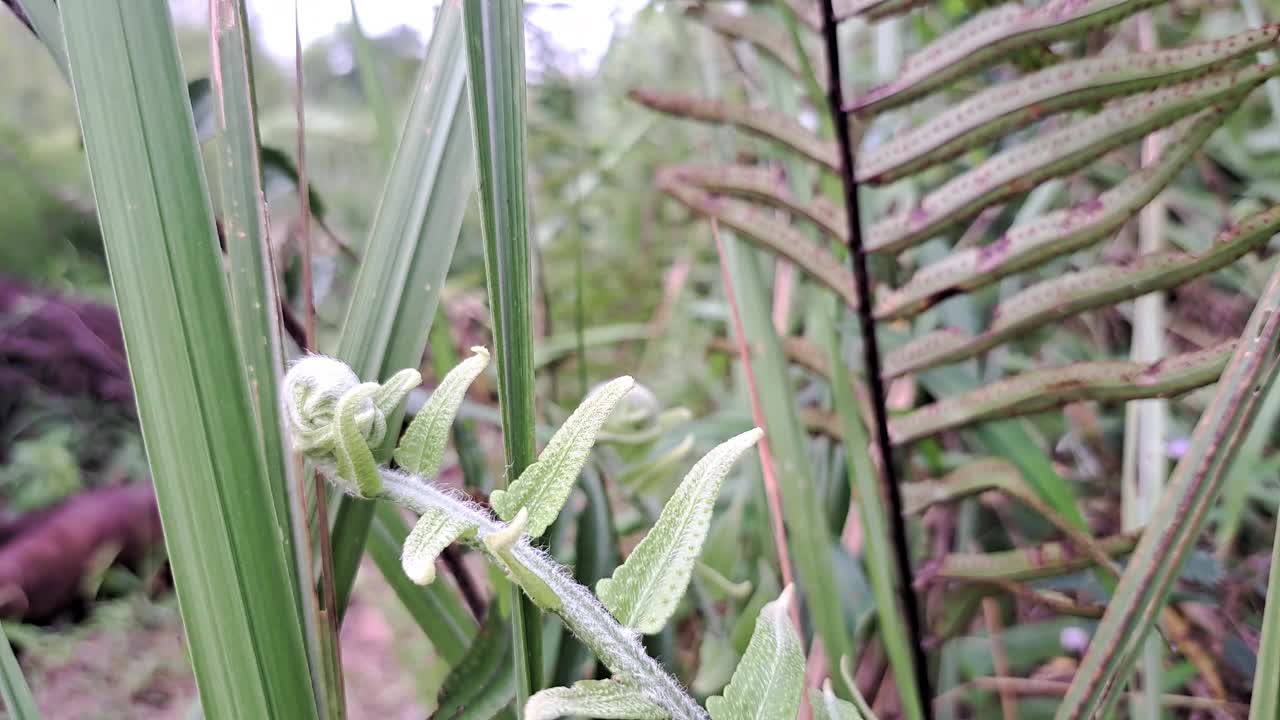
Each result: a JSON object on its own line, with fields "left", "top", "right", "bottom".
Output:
{"left": 463, "top": 0, "right": 543, "bottom": 708}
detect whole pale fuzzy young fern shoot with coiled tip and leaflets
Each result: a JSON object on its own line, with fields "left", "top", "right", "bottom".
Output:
{"left": 283, "top": 347, "right": 829, "bottom": 720}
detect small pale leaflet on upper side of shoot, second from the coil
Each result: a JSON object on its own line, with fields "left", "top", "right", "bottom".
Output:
{"left": 396, "top": 347, "right": 489, "bottom": 478}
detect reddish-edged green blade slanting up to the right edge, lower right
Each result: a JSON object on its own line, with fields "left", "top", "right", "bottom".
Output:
{"left": 1057, "top": 248, "right": 1280, "bottom": 720}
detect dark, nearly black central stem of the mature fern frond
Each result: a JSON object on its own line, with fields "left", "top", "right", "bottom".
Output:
{"left": 822, "top": 0, "right": 933, "bottom": 707}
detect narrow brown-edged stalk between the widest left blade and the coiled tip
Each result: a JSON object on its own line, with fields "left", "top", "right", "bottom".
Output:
{"left": 210, "top": 0, "right": 346, "bottom": 717}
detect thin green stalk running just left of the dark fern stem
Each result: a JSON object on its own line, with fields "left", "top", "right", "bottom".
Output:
{"left": 818, "top": 304, "right": 924, "bottom": 719}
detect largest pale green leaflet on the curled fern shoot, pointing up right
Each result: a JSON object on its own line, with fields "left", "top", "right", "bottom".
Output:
{"left": 595, "top": 428, "right": 764, "bottom": 634}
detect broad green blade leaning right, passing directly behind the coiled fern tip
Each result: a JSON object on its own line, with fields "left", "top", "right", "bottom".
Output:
{"left": 325, "top": 4, "right": 475, "bottom": 609}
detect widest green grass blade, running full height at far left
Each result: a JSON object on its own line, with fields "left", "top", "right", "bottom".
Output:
{"left": 60, "top": 0, "right": 317, "bottom": 717}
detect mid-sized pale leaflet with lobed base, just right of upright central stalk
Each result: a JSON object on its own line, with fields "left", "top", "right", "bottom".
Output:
{"left": 489, "top": 375, "right": 635, "bottom": 538}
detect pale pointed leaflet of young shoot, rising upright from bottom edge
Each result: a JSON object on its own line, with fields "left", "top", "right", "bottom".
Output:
{"left": 707, "top": 585, "right": 804, "bottom": 720}
